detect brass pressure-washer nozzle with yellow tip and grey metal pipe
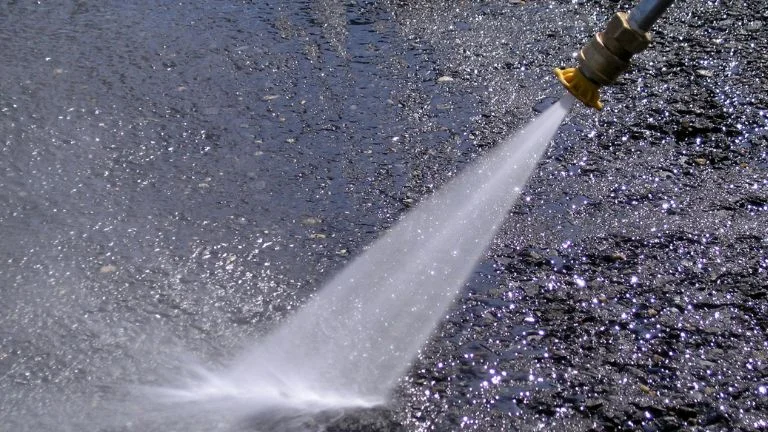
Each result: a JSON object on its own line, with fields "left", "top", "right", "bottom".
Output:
{"left": 555, "top": 0, "right": 672, "bottom": 109}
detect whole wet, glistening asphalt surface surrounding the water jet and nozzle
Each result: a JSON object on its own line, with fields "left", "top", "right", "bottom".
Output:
{"left": 0, "top": 0, "right": 768, "bottom": 431}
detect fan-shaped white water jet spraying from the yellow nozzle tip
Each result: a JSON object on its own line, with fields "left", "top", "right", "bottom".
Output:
{"left": 156, "top": 95, "right": 574, "bottom": 418}
